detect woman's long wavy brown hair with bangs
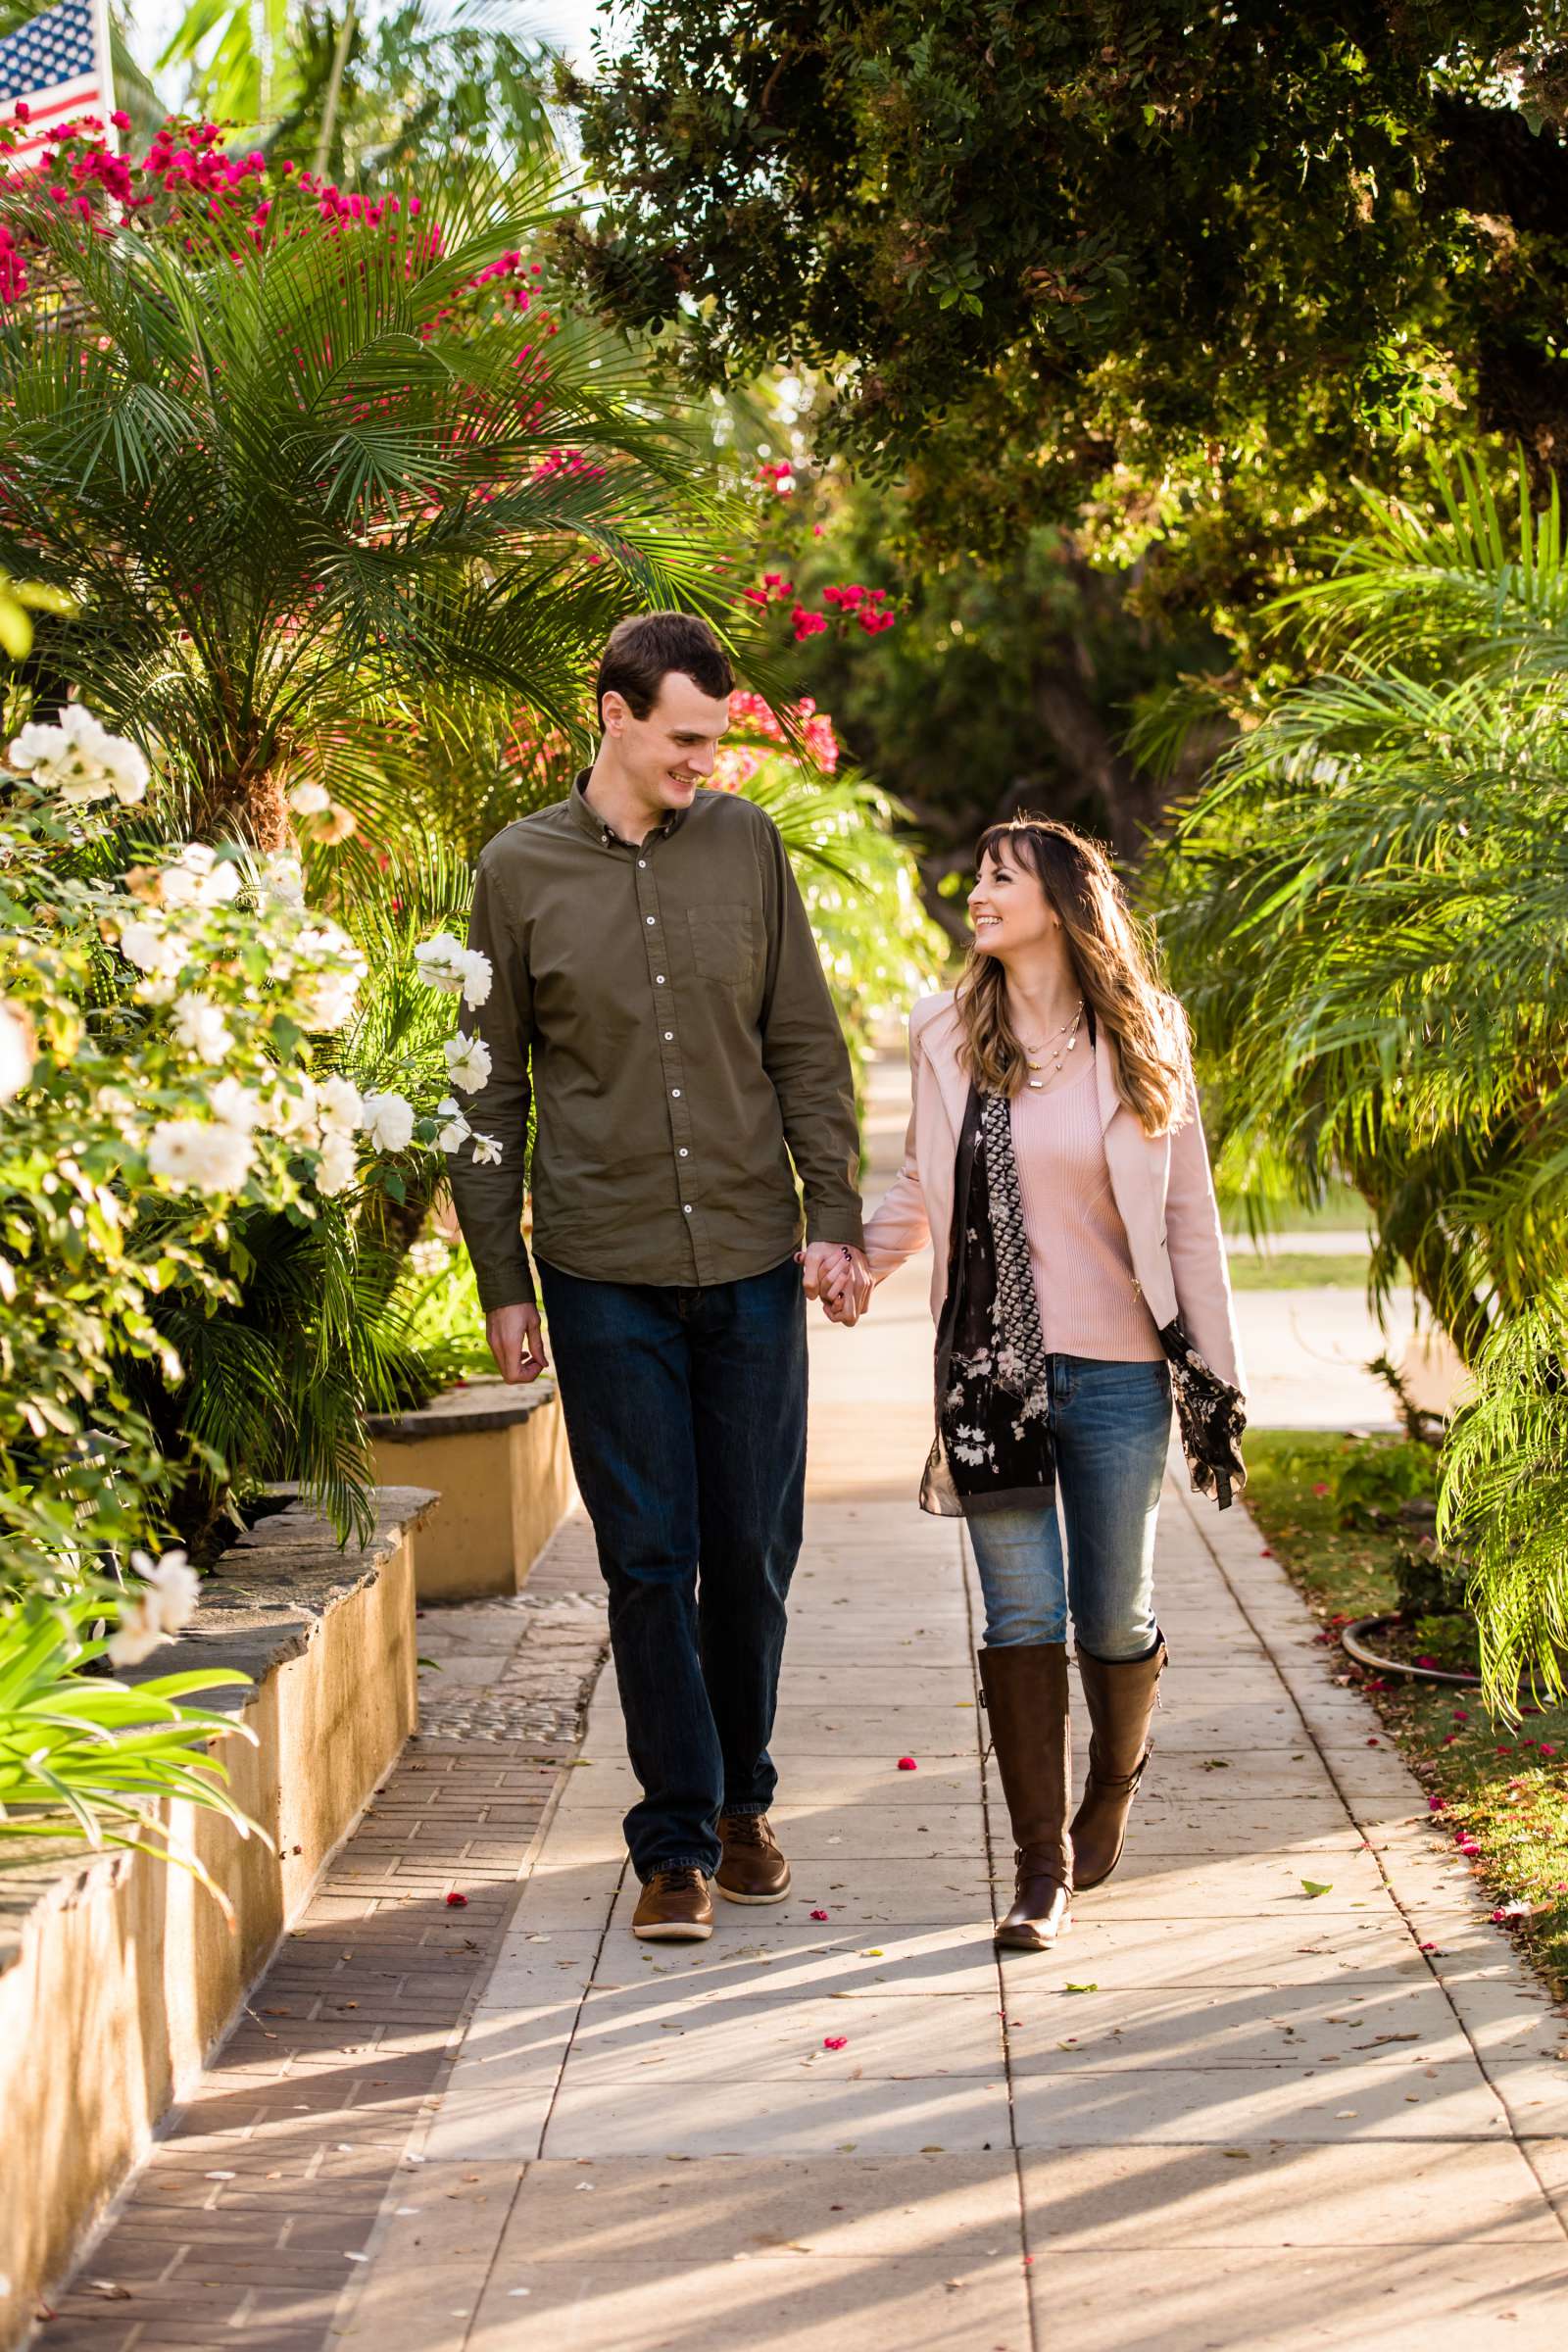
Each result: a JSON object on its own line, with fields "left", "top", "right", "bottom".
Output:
{"left": 956, "top": 816, "right": 1187, "bottom": 1136}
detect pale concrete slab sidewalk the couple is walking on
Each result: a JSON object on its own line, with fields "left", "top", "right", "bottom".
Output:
{"left": 338, "top": 1270, "right": 1568, "bottom": 2352}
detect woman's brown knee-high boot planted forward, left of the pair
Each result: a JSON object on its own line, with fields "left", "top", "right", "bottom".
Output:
{"left": 980, "top": 1642, "right": 1072, "bottom": 1952}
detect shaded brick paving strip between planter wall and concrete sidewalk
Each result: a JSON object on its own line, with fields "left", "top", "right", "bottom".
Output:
{"left": 42, "top": 1522, "right": 604, "bottom": 2352}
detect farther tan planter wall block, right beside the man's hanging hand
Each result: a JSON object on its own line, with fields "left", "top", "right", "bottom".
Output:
{"left": 371, "top": 1376, "right": 573, "bottom": 1601}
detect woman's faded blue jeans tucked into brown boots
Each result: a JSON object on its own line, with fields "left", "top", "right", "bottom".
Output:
{"left": 966, "top": 1354, "right": 1171, "bottom": 1665}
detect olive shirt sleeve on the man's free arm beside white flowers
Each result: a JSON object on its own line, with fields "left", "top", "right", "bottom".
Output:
{"left": 452, "top": 852, "right": 534, "bottom": 1315}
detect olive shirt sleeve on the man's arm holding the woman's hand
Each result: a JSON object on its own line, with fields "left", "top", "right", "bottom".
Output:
{"left": 761, "top": 823, "right": 865, "bottom": 1249}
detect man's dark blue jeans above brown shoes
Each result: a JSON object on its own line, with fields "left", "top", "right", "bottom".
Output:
{"left": 538, "top": 1258, "right": 807, "bottom": 1880}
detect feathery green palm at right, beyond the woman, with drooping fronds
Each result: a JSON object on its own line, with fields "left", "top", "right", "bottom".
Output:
{"left": 1156, "top": 464, "right": 1568, "bottom": 1705}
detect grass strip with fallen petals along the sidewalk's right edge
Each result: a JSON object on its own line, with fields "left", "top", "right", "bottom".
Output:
{"left": 1246, "top": 1430, "right": 1568, "bottom": 1999}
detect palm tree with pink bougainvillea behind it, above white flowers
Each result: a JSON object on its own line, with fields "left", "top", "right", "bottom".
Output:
{"left": 0, "top": 135, "right": 729, "bottom": 847}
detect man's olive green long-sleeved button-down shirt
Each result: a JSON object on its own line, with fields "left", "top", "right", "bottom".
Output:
{"left": 452, "top": 776, "right": 860, "bottom": 1312}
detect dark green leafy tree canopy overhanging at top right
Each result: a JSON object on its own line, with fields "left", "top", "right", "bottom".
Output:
{"left": 566, "top": 0, "right": 1568, "bottom": 612}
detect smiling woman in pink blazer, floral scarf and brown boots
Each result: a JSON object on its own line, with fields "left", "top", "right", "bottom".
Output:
{"left": 827, "top": 818, "right": 1244, "bottom": 1950}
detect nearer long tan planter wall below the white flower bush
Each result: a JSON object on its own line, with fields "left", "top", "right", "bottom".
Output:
{"left": 0, "top": 1487, "right": 435, "bottom": 2347}
